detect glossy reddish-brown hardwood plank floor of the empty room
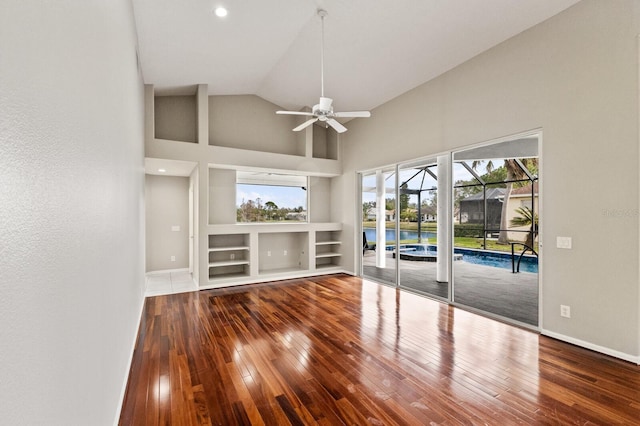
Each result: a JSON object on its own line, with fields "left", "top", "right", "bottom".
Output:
{"left": 120, "top": 275, "right": 640, "bottom": 426}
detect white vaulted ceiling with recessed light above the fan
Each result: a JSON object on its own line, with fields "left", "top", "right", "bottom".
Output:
{"left": 133, "top": 0, "right": 578, "bottom": 115}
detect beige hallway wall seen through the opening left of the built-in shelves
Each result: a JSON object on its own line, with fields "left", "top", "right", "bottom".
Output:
{"left": 145, "top": 175, "right": 189, "bottom": 272}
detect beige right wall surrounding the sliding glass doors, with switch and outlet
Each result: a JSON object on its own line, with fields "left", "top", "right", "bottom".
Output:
{"left": 336, "top": 0, "right": 640, "bottom": 357}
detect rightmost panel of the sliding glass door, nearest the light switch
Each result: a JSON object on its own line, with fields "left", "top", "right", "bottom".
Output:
{"left": 453, "top": 136, "right": 539, "bottom": 326}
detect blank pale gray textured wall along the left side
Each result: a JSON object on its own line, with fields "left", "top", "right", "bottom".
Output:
{"left": 0, "top": 0, "right": 144, "bottom": 425}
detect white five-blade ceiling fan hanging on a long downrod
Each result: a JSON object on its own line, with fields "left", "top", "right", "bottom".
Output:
{"left": 276, "top": 9, "right": 371, "bottom": 133}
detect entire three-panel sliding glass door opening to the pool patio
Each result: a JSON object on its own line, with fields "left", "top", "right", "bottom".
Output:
{"left": 360, "top": 133, "right": 540, "bottom": 327}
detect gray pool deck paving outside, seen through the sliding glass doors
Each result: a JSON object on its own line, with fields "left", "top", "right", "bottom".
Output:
{"left": 363, "top": 251, "right": 538, "bottom": 326}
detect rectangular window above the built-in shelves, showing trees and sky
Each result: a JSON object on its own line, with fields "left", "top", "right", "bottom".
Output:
{"left": 236, "top": 170, "right": 308, "bottom": 223}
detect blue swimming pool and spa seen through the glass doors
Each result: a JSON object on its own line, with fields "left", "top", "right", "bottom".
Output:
{"left": 386, "top": 244, "right": 538, "bottom": 274}
